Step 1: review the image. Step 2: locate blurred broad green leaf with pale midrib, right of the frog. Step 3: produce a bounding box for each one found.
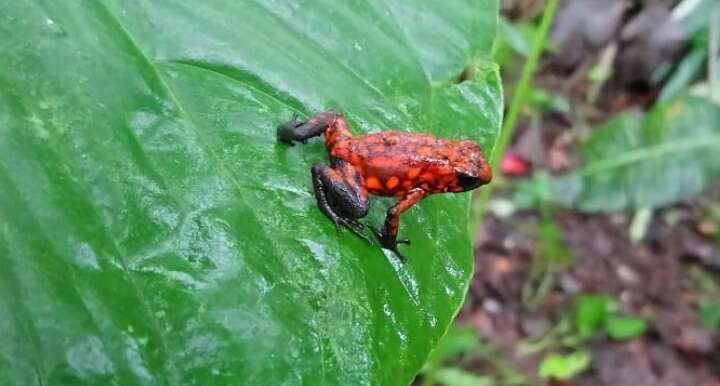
[552,97,720,211]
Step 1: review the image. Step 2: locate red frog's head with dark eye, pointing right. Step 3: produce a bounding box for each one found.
[448,141,492,192]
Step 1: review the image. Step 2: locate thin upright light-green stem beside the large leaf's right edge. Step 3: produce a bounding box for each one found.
[470,0,560,232]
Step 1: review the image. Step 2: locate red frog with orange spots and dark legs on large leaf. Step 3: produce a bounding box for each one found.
[276,110,492,262]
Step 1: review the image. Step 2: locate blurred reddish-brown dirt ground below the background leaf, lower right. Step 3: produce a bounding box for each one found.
[459,196,720,386]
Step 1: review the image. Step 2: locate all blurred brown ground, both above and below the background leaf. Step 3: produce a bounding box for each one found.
[458,0,720,386]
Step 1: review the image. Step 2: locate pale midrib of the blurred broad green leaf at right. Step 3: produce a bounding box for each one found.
[573,135,720,177]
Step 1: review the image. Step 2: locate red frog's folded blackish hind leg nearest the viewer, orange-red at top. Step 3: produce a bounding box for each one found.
[312,161,370,242]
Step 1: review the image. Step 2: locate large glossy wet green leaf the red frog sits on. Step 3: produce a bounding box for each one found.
[0,0,501,386]
